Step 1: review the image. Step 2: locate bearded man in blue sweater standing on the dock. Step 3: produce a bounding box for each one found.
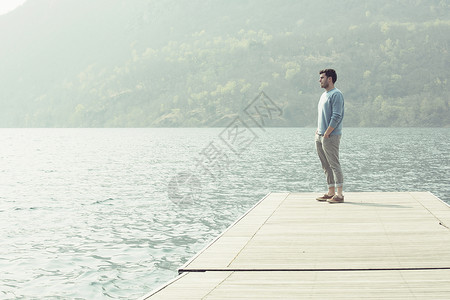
[315,69,344,203]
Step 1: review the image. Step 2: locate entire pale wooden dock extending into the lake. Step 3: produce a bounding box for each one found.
[142,192,450,300]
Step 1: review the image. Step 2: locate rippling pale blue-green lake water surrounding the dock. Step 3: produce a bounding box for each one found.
[0,128,450,299]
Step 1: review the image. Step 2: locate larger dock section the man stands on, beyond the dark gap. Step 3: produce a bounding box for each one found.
[182,193,450,271]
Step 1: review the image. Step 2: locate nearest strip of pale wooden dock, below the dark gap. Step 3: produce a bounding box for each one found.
[144,270,450,300]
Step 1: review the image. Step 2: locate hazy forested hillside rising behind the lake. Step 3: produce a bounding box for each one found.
[0,0,450,127]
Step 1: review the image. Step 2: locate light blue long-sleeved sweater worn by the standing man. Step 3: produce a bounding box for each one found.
[317,88,344,135]
